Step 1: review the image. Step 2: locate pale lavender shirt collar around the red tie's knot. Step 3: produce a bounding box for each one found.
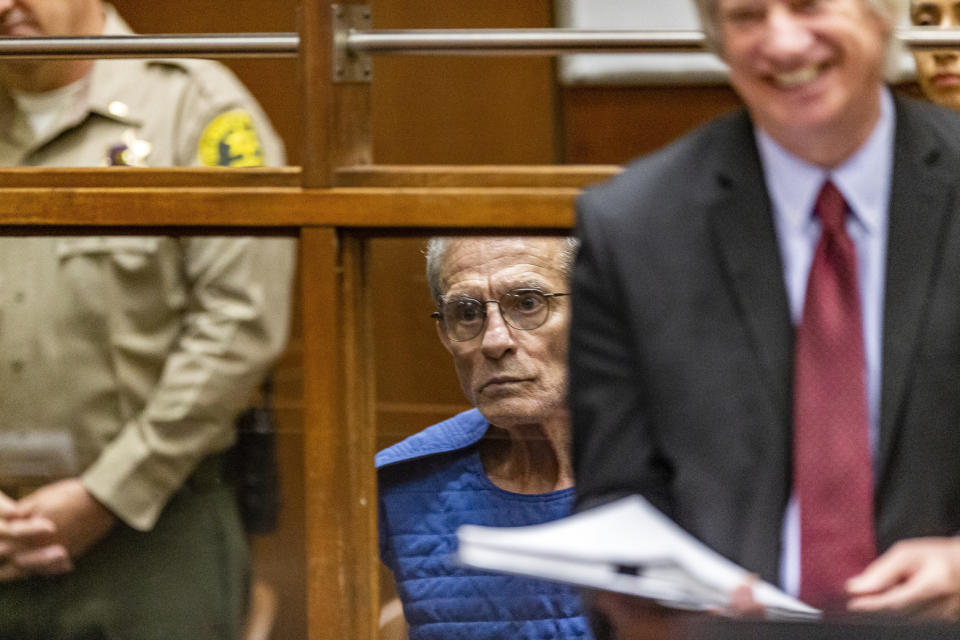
[755,87,895,233]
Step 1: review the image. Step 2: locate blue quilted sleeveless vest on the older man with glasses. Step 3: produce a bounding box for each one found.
[376,409,592,640]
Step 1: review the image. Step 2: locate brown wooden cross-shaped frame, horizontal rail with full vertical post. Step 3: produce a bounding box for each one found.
[0,0,616,640]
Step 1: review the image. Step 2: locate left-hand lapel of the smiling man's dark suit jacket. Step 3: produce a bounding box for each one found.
[708,115,793,437]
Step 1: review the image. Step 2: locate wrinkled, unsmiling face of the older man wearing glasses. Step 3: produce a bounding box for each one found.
[437,238,569,429]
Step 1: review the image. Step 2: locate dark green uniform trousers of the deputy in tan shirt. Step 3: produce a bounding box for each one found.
[0,475,249,640]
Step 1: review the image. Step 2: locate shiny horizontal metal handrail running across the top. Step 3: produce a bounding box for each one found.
[0,28,960,59]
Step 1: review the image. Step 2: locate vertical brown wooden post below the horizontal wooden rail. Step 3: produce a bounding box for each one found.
[301,228,379,640]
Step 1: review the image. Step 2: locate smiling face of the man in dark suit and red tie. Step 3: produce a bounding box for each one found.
[716,0,890,166]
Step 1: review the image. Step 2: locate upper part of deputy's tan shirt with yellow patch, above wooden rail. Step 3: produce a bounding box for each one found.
[0,6,285,167]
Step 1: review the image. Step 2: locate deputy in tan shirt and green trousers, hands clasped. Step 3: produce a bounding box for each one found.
[0,0,294,640]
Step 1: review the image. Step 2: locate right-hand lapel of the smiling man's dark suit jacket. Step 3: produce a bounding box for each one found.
[877,100,957,478]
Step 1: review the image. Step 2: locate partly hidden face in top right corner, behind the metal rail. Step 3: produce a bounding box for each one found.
[910,0,960,110]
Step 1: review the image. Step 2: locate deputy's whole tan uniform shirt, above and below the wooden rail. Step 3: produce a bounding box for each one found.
[0,8,294,530]
